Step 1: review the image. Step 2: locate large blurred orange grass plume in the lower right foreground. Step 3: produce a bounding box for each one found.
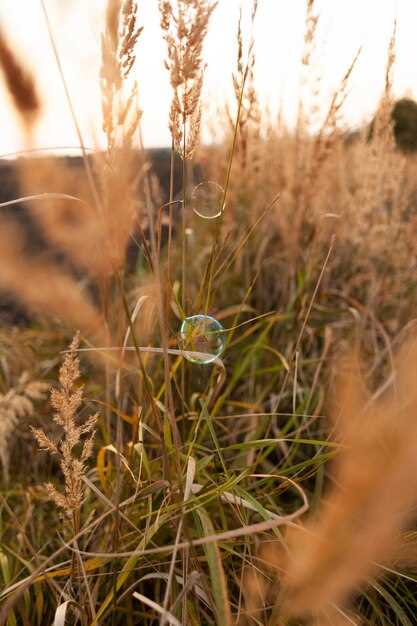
[254,340,417,623]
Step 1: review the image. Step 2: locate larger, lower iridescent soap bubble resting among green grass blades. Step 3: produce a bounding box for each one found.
[180,315,226,365]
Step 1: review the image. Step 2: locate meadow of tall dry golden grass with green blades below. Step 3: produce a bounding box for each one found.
[0,0,417,626]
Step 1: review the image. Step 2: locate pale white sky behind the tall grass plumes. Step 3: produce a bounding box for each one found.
[0,0,417,154]
